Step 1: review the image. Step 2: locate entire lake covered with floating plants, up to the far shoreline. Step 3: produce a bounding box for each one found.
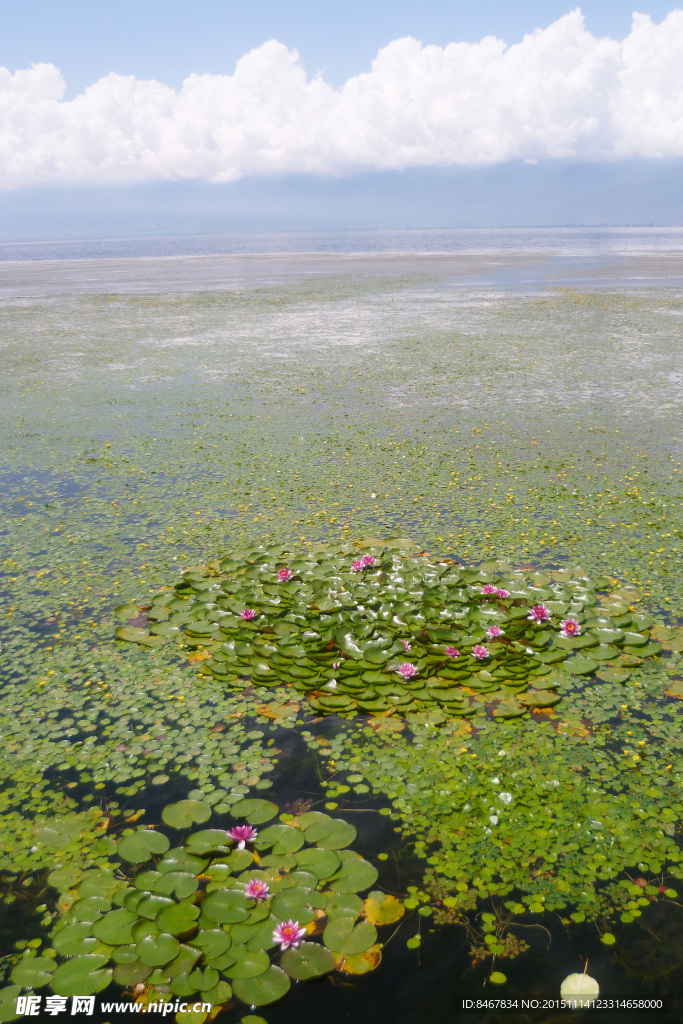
[0,228,683,1024]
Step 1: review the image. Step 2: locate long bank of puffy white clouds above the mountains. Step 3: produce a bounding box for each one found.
[0,10,683,187]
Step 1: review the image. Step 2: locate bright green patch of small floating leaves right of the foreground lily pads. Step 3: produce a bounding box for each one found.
[305,696,683,937]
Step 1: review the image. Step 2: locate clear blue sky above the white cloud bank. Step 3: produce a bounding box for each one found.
[0,0,675,98]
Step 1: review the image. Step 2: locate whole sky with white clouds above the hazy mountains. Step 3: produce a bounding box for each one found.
[0,0,683,207]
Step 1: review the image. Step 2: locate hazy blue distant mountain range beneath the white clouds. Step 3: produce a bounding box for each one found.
[0,160,683,242]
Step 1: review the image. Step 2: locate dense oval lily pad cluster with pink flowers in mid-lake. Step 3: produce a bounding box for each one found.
[117,538,659,718]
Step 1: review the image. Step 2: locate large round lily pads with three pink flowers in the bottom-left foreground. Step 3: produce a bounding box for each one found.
[10,799,403,1007]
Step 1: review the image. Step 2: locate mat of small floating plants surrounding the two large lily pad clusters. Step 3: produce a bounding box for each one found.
[0,259,683,1021]
